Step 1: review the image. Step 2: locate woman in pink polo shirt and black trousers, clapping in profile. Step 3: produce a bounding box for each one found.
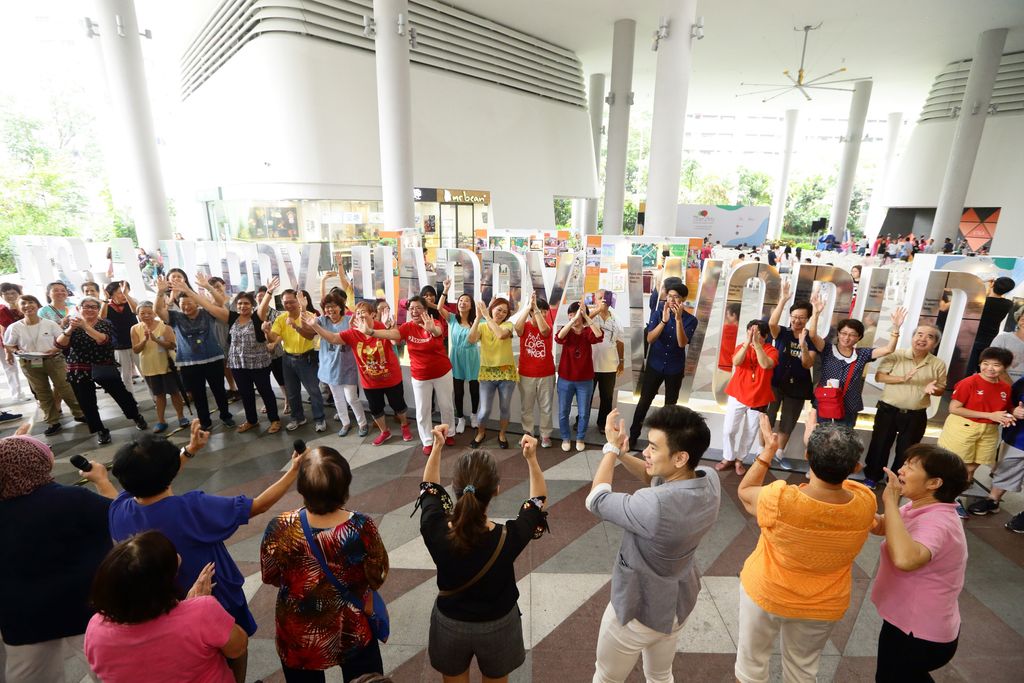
[871,443,968,683]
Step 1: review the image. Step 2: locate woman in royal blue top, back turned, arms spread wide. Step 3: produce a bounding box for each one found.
[110,421,305,681]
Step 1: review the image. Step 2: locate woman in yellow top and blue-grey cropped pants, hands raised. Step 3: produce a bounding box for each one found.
[469,297,519,449]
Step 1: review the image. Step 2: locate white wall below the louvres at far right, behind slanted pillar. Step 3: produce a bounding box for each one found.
[885,114,1024,256]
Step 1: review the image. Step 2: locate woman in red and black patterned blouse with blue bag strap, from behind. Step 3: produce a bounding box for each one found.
[260,446,388,682]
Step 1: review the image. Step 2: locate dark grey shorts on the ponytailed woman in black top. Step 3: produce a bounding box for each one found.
[427,602,526,678]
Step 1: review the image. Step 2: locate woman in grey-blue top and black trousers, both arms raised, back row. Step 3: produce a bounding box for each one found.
[156,275,236,431]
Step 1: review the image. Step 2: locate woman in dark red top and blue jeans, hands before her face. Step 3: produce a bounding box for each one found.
[555,301,604,453]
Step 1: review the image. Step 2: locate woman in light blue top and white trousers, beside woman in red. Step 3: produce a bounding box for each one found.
[315,290,370,436]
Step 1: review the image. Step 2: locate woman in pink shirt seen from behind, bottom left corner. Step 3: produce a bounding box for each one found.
[85,531,249,683]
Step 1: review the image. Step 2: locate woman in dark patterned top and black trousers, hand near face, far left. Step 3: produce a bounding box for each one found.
[55,297,148,445]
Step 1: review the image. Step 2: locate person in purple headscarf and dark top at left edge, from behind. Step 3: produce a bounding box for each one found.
[0,424,117,682]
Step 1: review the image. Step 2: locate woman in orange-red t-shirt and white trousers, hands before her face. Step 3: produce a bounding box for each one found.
[715,321,778,474]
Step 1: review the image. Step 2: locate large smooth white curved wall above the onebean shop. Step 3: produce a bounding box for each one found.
[182,35,597,237]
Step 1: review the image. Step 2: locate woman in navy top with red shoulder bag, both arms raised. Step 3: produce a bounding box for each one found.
[802,294,906,428]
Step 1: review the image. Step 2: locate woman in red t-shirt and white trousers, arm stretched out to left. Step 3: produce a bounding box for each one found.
[374,296,455,456]
